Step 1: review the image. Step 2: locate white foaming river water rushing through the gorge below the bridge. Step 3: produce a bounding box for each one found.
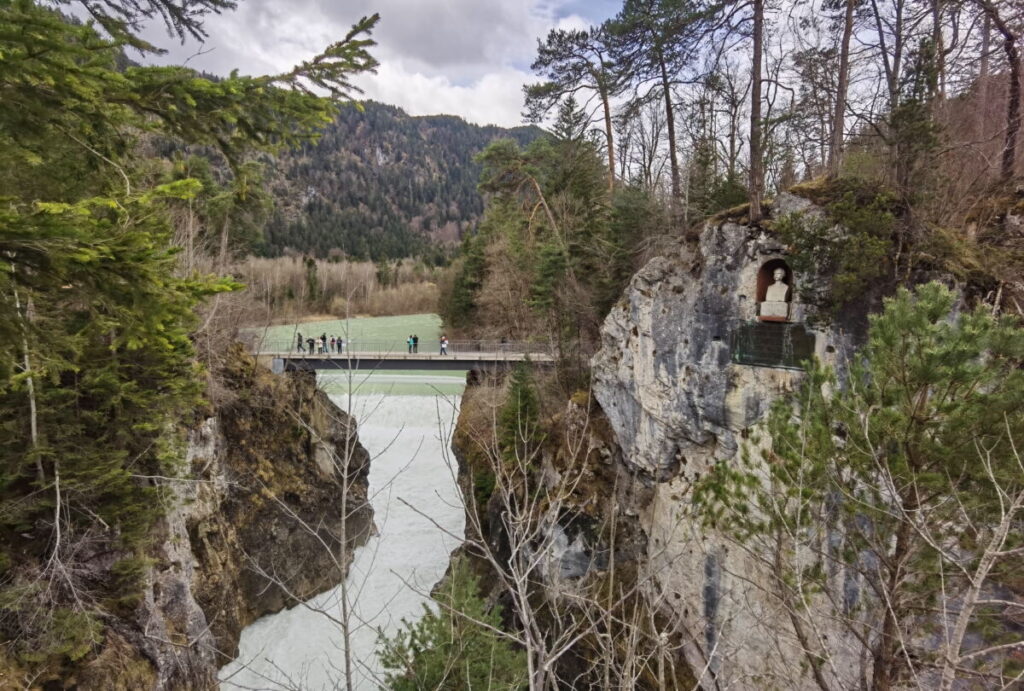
[220,386,465,691]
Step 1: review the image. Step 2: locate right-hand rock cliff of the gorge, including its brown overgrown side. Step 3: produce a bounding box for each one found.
[453,193,886,689]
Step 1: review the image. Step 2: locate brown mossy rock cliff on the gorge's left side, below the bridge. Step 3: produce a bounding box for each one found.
[74,351,373,689]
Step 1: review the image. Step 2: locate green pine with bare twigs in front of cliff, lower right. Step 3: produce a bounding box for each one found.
[694,283,1024,688]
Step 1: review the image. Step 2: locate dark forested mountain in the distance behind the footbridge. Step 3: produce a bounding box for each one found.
[262,101,541,260]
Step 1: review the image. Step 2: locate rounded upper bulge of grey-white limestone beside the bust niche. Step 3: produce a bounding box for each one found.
[593,195,847,478]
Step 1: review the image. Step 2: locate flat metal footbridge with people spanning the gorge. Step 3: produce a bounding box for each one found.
[252,339,555,372]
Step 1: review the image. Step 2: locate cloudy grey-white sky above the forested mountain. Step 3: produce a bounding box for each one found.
[133,0,621,126]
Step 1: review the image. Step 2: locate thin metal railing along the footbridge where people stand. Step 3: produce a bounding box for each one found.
[250,338,553,359]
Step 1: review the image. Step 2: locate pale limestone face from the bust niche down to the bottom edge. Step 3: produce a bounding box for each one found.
[592,195,864,689]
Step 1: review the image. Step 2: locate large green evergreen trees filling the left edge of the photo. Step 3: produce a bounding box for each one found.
[0,0,376,679]
